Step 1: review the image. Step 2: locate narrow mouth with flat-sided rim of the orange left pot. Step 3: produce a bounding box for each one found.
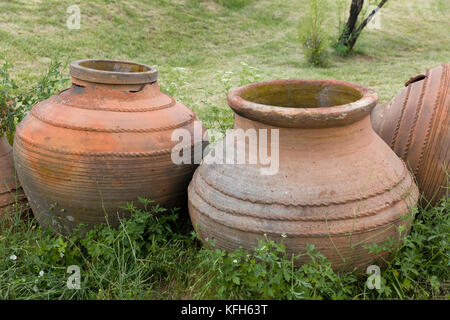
[70,59,158,84]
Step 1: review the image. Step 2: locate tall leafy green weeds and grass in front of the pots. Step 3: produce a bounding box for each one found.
[0,199,450,299]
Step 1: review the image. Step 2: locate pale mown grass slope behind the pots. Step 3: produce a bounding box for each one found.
[0,0,450,111]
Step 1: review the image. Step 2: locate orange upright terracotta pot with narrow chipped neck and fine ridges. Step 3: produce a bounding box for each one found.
[14,60,203,232]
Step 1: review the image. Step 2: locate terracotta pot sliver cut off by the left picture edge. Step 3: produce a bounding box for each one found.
[0,136,26,219]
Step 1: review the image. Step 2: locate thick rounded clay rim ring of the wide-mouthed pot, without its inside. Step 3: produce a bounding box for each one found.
[227,79,378,128]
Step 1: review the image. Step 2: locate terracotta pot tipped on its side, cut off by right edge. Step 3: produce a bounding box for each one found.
[371,64,450,204]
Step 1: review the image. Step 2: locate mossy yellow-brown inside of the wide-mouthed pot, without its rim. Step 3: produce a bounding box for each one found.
[241,81,363,108]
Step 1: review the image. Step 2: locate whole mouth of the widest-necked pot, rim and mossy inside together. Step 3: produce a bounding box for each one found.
[228,79,378,128]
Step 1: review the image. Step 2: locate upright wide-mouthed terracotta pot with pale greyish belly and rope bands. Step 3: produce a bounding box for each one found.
[189,80,418,269]
